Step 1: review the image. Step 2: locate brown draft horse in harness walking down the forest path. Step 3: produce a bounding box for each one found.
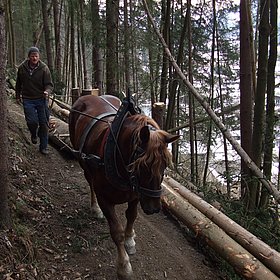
[69,95,178,279]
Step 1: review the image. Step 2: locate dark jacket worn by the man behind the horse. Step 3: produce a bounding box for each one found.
[16,59,53,99]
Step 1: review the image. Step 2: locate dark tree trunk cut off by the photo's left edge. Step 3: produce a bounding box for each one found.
[0,0,10,228]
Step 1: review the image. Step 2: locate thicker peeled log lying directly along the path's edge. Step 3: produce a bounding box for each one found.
[162,182,279,280]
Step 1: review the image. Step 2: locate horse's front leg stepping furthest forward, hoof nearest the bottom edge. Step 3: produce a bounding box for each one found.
[99,201,133,280]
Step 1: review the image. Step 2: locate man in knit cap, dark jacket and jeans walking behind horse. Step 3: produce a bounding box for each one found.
[16,47,53,155]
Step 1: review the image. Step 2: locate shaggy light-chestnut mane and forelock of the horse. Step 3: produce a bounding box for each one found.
[130,114,172,182]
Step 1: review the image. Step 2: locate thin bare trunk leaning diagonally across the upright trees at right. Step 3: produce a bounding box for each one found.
[143,0,280,203]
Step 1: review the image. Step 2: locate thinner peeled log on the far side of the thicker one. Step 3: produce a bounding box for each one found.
[164,177,280,278]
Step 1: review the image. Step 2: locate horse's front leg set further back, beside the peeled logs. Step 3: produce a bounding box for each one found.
[125,200,138,255]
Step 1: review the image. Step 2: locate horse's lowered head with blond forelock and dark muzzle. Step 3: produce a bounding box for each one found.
[122,115,179,214]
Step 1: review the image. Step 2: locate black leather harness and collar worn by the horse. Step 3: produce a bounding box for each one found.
[72,96,162,198]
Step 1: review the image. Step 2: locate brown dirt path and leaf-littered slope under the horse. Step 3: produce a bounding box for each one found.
[0,100,228,280]
